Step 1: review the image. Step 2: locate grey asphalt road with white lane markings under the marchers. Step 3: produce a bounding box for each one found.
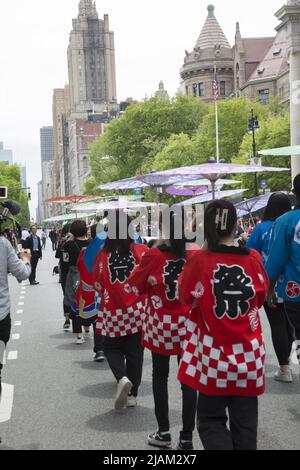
[0,242,300,450]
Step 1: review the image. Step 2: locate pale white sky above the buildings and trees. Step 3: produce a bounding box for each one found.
[0,0,284,216]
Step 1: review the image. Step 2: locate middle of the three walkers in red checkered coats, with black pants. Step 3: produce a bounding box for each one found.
[128,209,199,451]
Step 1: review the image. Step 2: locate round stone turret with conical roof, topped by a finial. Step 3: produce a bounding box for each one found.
[180,5,234,102]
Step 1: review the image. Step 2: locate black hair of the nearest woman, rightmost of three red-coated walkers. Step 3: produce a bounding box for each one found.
[204,199,237,251]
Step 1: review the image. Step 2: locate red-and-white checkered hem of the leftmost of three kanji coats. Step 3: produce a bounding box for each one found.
[96,302,145,338]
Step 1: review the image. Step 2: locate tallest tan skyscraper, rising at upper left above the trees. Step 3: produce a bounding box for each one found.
[68,0,117,119]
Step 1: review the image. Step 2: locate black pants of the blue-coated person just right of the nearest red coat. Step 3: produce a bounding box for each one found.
[265,303,294,366]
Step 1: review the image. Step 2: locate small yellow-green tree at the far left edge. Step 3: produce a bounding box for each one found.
[0,162,30,226]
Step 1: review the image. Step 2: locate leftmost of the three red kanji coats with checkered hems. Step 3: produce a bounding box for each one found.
[93,243,148,338]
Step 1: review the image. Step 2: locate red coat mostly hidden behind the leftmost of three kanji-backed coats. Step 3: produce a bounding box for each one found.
[72,250,98,320]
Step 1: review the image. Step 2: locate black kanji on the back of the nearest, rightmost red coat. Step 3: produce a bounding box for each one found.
[213,265,255,320]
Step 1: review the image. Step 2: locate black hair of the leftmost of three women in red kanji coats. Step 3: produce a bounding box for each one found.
[104,210,134,254]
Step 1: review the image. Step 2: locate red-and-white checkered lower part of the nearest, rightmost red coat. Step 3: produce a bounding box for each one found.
[180,321,266,395]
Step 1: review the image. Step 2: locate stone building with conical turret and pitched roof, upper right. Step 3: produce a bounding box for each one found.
[180,5,290,104]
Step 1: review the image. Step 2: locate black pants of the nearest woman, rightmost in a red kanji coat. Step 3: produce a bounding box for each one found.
[198,393,258,451]
